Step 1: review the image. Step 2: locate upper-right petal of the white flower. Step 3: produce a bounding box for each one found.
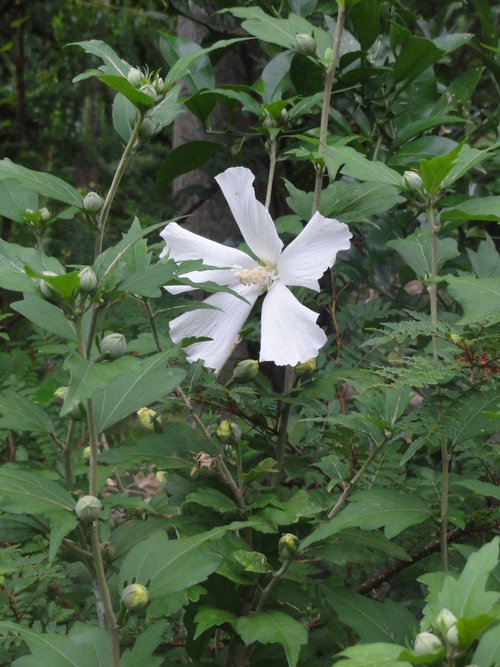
[278,213,352,291]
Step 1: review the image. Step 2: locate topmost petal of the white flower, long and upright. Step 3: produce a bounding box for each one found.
[215,167,283,265]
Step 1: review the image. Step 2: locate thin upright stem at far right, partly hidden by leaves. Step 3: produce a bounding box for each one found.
[426,204,450,571]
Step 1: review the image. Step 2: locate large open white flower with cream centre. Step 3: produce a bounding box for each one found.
[161,167,351,370]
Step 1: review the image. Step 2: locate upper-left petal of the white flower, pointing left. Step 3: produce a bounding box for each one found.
[160,222,255,268]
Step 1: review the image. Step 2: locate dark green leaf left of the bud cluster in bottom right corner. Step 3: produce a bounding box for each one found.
[324,586,418,646]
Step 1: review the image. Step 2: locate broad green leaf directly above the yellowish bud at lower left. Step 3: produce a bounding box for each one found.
[119,526,228,599]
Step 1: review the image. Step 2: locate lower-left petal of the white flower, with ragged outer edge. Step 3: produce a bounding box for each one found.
[170,283,261,369]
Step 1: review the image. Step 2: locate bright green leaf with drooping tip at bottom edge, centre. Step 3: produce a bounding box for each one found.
[236,610,308,667]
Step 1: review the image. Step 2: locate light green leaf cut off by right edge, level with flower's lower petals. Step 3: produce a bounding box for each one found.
[445,276,500,326]
